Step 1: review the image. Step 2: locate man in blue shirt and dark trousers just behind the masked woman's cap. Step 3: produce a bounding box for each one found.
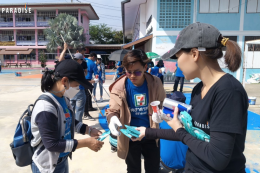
[85,53,98,120]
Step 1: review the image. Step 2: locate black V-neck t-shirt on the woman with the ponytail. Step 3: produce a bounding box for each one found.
[186,74,248,173]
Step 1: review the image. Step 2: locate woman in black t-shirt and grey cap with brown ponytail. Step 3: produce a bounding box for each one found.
[135,23,248,173]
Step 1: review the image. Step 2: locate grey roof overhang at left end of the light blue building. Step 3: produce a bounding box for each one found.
[121,0,147,41]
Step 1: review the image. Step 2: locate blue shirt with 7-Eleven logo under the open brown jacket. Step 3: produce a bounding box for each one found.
[125,79,150,127]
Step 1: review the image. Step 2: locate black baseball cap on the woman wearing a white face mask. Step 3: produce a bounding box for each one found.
[54,59,93,89]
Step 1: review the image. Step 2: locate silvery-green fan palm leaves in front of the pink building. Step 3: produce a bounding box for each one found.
[44,13,86,52]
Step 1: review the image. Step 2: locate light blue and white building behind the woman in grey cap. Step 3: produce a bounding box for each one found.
[121,0,260,82]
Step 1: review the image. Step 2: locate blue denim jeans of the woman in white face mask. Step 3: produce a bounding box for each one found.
[31,158,69,173]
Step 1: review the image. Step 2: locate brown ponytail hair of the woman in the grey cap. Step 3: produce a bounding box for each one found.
[200,35,242,72]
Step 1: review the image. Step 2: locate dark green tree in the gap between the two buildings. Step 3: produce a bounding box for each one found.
[89,24,130,44]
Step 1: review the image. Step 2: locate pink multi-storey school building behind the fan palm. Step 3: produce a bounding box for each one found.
[0,3,99,67]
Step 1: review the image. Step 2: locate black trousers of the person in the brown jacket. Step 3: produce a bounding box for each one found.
[125,139,160,173]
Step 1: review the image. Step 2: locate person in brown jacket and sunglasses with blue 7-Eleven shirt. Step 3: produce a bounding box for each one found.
[106,50,165,173]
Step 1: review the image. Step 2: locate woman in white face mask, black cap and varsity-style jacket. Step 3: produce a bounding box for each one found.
[31,59,103,173]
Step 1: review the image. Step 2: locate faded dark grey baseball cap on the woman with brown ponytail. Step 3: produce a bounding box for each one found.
[162,22,221,60]
